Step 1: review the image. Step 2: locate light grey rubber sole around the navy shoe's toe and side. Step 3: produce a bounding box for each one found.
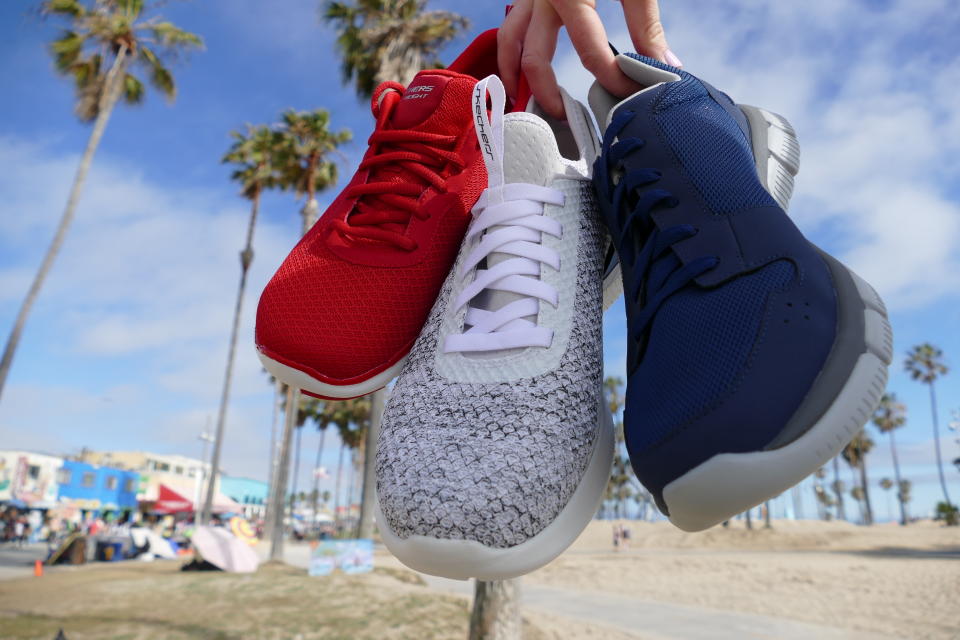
[663,271,893,531]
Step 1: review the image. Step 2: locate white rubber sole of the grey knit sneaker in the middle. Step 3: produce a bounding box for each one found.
[376,400,614,580]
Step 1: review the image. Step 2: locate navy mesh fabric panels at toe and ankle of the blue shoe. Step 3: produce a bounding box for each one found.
[612,54,796,455]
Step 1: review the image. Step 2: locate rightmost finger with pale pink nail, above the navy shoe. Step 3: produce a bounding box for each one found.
[557,2,640,97]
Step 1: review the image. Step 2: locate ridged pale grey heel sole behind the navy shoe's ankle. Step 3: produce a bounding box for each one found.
[739,104,800,211]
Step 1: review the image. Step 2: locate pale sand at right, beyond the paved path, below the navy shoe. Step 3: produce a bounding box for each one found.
[524,521,960,638]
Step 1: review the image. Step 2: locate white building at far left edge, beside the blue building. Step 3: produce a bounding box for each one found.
[0,450,63,510]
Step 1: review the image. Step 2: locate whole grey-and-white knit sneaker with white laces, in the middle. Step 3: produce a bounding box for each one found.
[377,76,614,580]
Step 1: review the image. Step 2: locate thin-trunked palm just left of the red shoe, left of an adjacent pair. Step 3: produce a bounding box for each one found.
[199,125,283,524]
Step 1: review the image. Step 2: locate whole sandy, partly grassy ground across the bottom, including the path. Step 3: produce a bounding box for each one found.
[0,521,960,640]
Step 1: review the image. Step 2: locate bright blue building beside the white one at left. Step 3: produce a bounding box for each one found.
[57,460,140,514]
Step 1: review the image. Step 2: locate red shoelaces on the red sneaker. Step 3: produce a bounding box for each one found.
[334,82,465,251]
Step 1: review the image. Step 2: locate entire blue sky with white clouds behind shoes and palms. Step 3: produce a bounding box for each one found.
[0,0,960,515]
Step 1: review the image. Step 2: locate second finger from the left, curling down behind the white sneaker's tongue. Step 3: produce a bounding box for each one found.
[511,0,563,119]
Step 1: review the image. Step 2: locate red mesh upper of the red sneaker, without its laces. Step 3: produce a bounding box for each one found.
[256,71,486,380]
